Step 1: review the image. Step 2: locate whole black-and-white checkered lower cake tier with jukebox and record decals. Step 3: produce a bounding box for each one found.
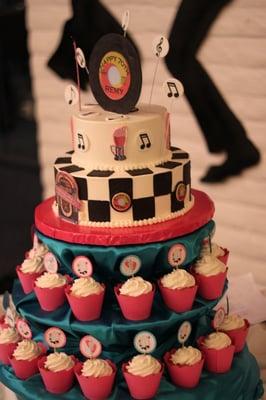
[54,147,193,227]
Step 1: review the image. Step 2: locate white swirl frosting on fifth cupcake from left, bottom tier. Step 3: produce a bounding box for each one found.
[126,354,161,376]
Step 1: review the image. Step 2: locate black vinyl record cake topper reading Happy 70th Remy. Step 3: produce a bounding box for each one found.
[89,33,142,114]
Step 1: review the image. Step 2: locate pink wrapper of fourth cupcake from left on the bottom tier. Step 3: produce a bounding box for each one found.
[74,360,117,400]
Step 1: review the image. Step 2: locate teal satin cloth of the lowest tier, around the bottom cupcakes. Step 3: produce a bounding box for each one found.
[0,348,263,400]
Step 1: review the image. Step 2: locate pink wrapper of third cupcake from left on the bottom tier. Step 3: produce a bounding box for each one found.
[38,356,76,394]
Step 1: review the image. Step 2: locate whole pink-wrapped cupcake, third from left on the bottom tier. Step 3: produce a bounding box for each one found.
[38,352,76,394]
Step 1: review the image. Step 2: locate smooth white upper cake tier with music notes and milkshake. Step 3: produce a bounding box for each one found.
[71,105,171,171]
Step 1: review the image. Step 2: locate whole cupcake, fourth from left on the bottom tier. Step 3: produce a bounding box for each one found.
[75,358,116,400]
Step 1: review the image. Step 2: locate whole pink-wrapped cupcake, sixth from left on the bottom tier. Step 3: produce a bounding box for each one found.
[164,346,204,388]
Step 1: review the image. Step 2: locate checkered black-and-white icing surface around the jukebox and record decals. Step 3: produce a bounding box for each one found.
[55,147,191,223]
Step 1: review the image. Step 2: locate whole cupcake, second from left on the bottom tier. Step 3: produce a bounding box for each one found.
[10,340,46,380]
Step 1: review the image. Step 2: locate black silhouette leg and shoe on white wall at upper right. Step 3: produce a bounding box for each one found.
[165,0,260,182]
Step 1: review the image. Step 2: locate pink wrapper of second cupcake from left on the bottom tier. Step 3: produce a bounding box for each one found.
[9,343,47,380]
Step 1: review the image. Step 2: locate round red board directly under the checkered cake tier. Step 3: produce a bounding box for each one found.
[35,189,214,246]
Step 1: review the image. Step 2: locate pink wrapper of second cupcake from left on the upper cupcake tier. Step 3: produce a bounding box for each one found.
[34,275,72,311]
